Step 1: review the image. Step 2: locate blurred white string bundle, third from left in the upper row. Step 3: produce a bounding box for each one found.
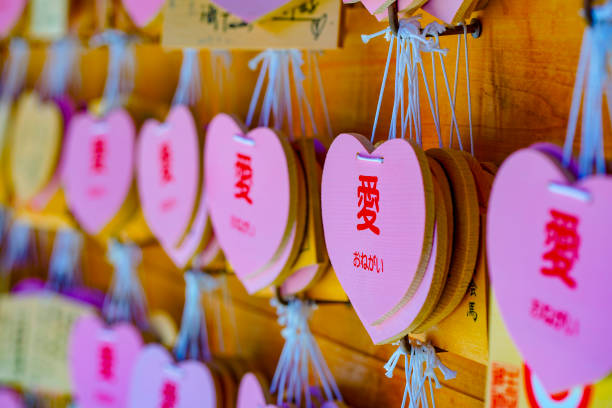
[90,30,135,114]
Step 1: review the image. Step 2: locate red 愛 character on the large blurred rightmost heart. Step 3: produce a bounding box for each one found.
[541,210,580,289]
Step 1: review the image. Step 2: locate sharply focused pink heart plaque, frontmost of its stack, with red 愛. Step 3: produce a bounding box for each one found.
[321,133,435,325]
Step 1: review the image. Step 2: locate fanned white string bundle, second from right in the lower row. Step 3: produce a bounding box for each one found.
[270,299,342,408]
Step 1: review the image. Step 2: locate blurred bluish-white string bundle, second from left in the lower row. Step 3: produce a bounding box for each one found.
[47,228,83,292]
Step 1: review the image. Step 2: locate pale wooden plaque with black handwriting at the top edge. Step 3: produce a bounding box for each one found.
[162,0,340,50]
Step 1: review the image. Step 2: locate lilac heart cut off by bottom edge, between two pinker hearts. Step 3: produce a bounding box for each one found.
[126,344,218,408]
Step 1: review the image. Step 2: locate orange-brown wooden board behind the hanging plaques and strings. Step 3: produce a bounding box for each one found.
[7,0,609,408]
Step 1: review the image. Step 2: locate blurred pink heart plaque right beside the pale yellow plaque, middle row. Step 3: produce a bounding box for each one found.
[62,109,135,235]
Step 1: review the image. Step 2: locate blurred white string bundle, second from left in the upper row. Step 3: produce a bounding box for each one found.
[38,37,80,98]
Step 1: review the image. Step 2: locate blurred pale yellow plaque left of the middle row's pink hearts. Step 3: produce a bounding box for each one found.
[10,92,63,203]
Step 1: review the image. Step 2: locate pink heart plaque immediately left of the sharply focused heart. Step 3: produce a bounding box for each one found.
[204,114,298,279]
